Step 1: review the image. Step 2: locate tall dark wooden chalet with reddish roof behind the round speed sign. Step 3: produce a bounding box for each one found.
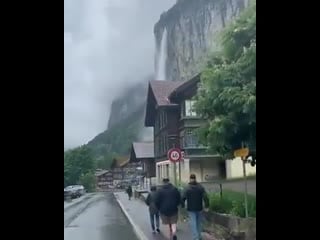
[145,75,255,183]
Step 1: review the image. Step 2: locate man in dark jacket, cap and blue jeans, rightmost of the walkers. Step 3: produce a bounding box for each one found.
[182,174,209,240]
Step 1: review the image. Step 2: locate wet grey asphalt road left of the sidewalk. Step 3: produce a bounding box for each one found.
[64,193,138,240]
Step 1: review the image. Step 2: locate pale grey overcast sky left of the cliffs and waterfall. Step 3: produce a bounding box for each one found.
[64,0,175,148]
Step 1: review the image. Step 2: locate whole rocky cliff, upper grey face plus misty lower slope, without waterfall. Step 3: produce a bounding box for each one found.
[88,0,248,163]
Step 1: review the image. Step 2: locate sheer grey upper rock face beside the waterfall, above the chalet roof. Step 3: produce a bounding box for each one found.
[154,0,248,81]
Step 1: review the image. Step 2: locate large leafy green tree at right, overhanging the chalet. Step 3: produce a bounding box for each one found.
[195,2,256,156]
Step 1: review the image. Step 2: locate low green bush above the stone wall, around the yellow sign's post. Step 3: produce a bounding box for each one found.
[209,191,256,217]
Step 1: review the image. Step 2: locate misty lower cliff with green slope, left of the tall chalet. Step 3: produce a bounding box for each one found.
[87,76,153,159]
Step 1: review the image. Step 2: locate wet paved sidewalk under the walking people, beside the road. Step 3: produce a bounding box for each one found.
[114,192,212,240]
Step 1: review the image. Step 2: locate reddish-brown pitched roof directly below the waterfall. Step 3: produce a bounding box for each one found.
[150,80,184,106]
